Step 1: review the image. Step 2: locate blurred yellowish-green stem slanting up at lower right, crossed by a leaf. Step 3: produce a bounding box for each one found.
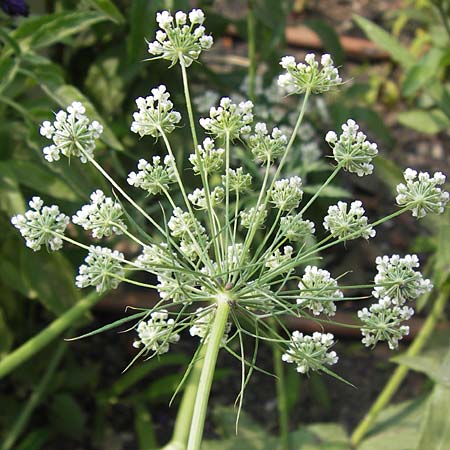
[351,283,450,447]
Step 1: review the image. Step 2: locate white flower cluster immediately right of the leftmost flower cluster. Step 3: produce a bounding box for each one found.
[72,189,127,239]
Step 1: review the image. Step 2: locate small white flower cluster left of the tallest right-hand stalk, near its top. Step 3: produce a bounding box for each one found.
[248,123,287,164]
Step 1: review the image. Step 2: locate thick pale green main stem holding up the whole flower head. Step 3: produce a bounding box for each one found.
[187,293,231,450]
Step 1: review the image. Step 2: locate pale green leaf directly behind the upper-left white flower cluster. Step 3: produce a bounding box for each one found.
[41,84,124,151]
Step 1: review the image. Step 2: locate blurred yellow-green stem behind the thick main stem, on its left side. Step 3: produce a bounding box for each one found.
[163,346,206,450]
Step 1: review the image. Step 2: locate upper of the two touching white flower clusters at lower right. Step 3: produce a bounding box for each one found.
[372,255,433,305]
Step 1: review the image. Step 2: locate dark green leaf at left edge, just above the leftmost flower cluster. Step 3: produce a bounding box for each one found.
[4,160,78,201]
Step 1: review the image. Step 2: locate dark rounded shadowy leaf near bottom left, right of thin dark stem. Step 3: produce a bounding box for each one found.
[50,393,86,441]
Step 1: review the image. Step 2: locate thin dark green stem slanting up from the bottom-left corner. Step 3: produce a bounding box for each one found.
[1,342,67,450]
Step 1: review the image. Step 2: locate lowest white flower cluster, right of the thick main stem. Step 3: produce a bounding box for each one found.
[282,331,339,373]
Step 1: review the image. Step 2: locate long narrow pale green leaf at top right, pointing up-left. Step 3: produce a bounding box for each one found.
[353,15,414,69]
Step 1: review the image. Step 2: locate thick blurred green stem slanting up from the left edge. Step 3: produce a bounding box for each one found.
[0,292,101,379]
